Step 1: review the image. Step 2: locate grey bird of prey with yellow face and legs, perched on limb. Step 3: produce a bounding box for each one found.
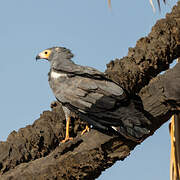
[36,47,151,143]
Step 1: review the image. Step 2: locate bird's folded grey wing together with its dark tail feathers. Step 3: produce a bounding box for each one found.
[55,76,150,140]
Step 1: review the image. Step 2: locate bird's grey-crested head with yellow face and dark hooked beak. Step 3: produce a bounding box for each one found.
[36,47,73,62]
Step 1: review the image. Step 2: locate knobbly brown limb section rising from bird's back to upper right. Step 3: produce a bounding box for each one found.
[106,2,180,93]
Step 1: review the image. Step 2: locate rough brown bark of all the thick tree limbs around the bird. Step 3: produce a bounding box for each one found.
[0,3,180,180]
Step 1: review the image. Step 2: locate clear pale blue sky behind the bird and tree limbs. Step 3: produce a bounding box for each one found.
[0,0,176,180]
